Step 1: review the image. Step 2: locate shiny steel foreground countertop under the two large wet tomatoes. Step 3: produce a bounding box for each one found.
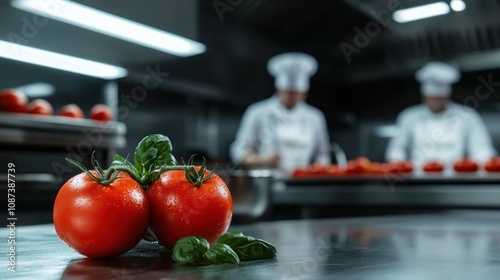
[0,211,500,280]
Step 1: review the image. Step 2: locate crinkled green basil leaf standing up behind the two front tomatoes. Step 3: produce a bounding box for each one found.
[134,134,177,177]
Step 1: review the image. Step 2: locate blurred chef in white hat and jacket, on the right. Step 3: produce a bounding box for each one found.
[386,62,496,167]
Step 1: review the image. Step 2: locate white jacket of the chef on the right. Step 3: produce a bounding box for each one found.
[386,102,496,166]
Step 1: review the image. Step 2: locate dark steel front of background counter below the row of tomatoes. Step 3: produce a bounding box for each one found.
[272,171,500,218]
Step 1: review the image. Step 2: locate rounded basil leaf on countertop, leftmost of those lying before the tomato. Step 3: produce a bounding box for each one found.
[172,236,210,263]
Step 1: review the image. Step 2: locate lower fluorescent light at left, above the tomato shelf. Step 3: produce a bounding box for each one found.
[0,40,127,80]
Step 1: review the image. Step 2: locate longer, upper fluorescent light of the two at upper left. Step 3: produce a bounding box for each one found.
[11,0,206,56]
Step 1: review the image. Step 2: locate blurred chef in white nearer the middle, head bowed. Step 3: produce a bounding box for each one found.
[230,52,331,175]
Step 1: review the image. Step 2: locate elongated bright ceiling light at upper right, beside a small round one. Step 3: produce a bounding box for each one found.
[392,2,450,23]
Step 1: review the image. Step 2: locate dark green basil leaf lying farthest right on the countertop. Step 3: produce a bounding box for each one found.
[219,234,278,261]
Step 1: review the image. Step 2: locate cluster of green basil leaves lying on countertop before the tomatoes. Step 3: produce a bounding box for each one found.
[172,231,278,264]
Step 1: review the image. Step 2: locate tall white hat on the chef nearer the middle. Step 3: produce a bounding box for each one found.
[267,52,318,93]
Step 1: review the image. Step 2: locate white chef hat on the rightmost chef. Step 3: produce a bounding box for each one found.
[415,61,460,97]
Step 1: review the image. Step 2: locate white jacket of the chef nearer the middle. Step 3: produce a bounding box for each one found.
[230,95,331,173]
